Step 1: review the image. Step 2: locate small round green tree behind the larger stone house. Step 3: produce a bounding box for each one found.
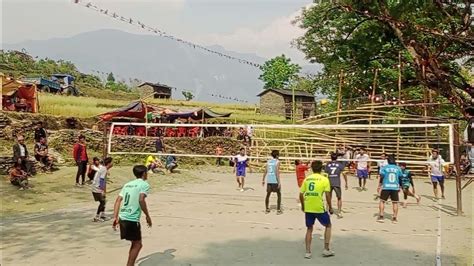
[259,55,301,89]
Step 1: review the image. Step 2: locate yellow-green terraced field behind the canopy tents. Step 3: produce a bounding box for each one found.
[39,92,285,123]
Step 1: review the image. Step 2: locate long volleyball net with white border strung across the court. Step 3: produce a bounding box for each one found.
[107,122,454,164]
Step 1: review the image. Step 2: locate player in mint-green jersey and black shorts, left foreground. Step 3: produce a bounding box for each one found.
[112,165,152,266]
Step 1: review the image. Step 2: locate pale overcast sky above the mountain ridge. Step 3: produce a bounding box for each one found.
[0,0,312,63]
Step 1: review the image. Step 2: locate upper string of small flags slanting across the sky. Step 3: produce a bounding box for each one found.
[74,0,261,68]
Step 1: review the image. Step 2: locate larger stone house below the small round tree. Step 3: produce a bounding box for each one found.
[257,89,316,119]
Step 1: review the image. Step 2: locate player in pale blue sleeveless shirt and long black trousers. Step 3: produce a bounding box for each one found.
[262,150,283,214]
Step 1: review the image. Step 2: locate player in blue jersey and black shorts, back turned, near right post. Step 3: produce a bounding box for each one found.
[377,154,403,223]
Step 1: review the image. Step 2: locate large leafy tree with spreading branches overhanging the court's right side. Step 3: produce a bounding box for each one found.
[296,0,474,113]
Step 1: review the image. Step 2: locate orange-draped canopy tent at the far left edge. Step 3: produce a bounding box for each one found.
[0,73,38,113]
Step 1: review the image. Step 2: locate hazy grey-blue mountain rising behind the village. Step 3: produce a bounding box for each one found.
[3,30,320,103]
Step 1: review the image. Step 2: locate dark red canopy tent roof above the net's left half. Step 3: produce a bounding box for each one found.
[99,101,231,122]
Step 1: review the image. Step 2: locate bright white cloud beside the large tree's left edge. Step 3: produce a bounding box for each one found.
[197,6,305,63]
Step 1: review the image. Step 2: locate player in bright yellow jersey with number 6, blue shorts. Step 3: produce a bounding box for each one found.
[300,161,334,259]
